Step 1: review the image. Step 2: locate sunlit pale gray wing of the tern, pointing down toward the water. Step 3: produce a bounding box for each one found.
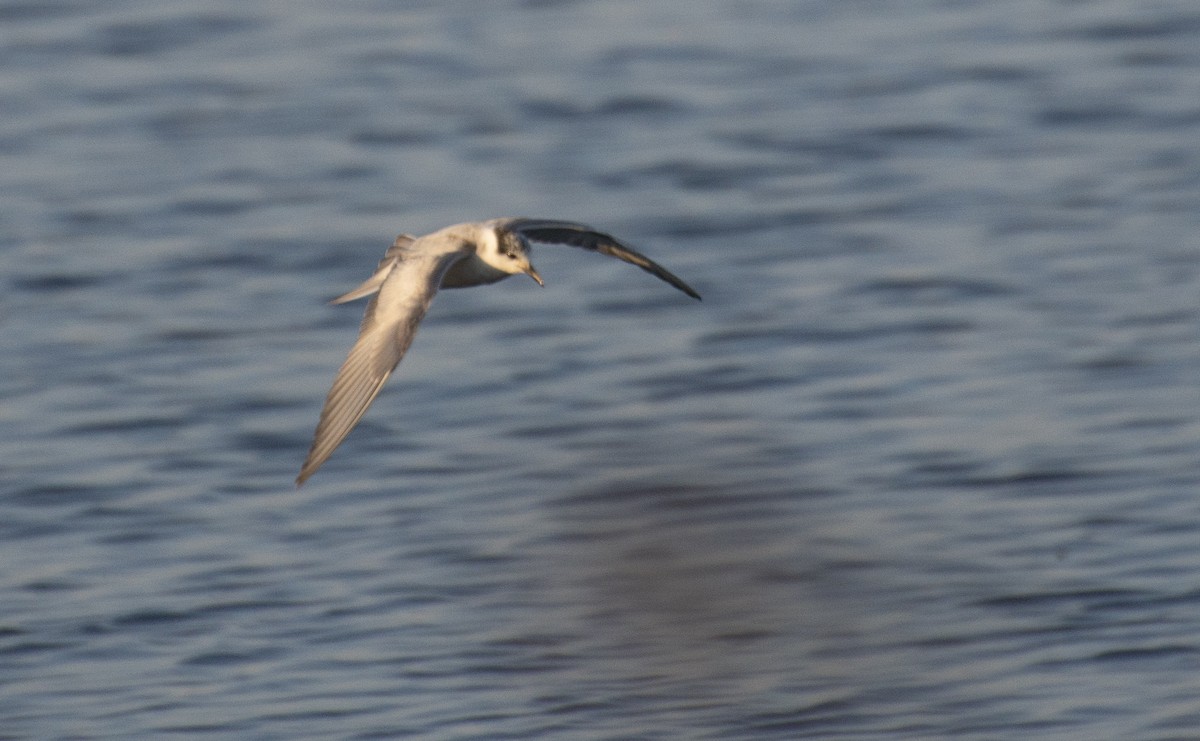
[296,242,467,486]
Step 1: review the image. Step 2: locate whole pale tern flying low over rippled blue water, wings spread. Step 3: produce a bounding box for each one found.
[295,217,700,487]
